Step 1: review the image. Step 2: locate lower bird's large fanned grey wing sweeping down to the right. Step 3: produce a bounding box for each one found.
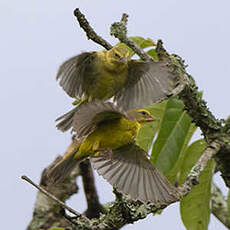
[90,144,178,204]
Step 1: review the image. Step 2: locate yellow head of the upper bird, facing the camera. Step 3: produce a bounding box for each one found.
[106,46,129,68]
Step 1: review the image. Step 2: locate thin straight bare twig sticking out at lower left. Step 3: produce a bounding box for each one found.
[21,176,89,221]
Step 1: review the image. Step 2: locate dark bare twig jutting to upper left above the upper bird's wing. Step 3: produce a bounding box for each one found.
[74,8,113,50]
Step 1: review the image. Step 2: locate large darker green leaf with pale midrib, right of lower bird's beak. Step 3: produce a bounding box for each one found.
[151,98,191,175]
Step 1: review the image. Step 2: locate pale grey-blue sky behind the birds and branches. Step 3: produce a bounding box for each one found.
[0,0,230,230]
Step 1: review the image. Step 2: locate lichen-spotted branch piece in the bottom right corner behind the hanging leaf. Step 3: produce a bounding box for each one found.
[211,184,230,229]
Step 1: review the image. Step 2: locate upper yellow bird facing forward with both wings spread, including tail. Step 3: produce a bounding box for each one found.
[57,46,179,131]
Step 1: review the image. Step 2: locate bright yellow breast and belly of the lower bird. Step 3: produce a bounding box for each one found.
[78,118,140,155]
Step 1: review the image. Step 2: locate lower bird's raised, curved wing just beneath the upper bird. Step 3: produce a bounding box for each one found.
[73,100,126,138]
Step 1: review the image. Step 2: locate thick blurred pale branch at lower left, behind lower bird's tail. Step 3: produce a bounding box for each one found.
[27,140,80,230]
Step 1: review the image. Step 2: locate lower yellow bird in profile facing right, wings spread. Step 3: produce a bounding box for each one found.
[48,100,178,203]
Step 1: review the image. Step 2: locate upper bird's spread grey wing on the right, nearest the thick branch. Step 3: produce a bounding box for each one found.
[114,59,180,110]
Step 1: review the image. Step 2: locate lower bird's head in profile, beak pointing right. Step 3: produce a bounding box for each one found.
[127,109,155,123]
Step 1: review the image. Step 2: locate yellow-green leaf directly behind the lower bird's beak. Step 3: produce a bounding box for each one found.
[136,101,167,152]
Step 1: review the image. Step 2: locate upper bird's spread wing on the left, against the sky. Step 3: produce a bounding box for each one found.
[56,52,97,98]
